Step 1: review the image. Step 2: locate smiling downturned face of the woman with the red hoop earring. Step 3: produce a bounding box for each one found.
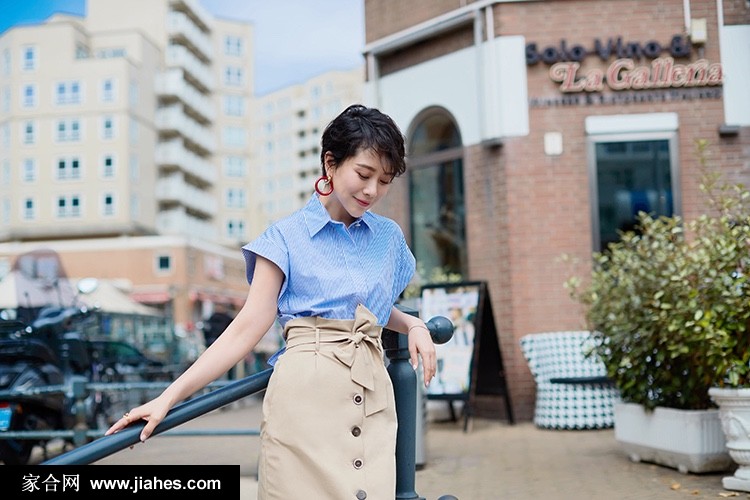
[321,149,393,225]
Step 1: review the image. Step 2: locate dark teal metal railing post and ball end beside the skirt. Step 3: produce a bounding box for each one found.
[383,307,453,500]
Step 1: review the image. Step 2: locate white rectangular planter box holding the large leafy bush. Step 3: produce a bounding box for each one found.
[614,403,733,473]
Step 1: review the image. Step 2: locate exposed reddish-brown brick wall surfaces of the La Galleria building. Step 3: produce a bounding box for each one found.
[366,0,750,420]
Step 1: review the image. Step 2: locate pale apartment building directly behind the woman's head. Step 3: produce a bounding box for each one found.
[248,67,364,239]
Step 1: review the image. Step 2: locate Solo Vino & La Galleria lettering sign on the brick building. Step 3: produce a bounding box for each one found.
[526,35,723,93]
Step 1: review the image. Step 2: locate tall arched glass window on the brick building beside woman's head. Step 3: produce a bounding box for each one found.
[409,110,468,276]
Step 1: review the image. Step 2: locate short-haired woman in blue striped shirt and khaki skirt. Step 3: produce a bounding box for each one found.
[107,105,435,500]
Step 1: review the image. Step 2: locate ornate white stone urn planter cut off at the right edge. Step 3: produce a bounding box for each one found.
[708,387,750,491]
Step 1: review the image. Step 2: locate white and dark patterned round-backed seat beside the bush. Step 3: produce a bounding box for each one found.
[521,331,620,429]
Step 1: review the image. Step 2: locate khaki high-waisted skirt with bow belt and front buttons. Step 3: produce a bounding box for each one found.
[258,305,396,500]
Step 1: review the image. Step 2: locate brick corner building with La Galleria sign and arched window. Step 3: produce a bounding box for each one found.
[364,0,750,419]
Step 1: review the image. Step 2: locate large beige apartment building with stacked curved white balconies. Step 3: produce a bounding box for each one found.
[0,0,253,331]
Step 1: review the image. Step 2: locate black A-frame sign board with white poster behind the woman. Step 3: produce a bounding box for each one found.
[421,281,514,430]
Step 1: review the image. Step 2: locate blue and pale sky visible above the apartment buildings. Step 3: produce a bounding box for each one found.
[0,0,365,95]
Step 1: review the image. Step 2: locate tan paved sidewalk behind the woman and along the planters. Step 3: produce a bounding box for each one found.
[44,397,750,500]
